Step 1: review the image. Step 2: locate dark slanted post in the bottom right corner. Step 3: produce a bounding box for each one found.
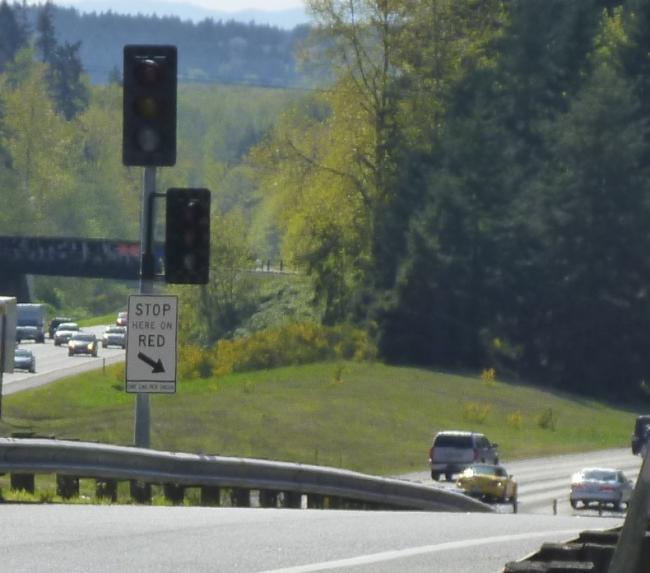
[608,447,650,573]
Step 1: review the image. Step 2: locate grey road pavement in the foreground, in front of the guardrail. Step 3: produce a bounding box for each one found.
[0,505,621,573]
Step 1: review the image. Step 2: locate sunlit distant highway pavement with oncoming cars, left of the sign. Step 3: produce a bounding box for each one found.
[2,325,124,395]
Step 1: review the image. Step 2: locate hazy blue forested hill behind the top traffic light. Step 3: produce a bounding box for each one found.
[22,0,309,87]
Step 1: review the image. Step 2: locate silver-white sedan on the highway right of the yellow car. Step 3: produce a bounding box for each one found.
[569,468,634,511]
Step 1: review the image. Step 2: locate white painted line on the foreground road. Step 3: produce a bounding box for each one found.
[260,529,580,573]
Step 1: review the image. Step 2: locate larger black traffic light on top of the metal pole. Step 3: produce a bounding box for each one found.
[122,45,177,167]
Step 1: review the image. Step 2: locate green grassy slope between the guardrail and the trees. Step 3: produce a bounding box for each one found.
[0,363,635,474]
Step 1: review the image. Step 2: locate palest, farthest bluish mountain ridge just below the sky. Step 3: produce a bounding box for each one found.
[55,0,308,30]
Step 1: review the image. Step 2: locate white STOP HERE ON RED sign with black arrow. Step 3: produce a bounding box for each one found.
[126,295,178,394]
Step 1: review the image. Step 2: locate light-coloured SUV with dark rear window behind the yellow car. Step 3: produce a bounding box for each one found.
[429,431,499,481]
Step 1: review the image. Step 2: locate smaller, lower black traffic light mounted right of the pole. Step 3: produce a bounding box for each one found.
[165,189,210,284]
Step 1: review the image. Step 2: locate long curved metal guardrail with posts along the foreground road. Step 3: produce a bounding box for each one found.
[0,438,493,512]
